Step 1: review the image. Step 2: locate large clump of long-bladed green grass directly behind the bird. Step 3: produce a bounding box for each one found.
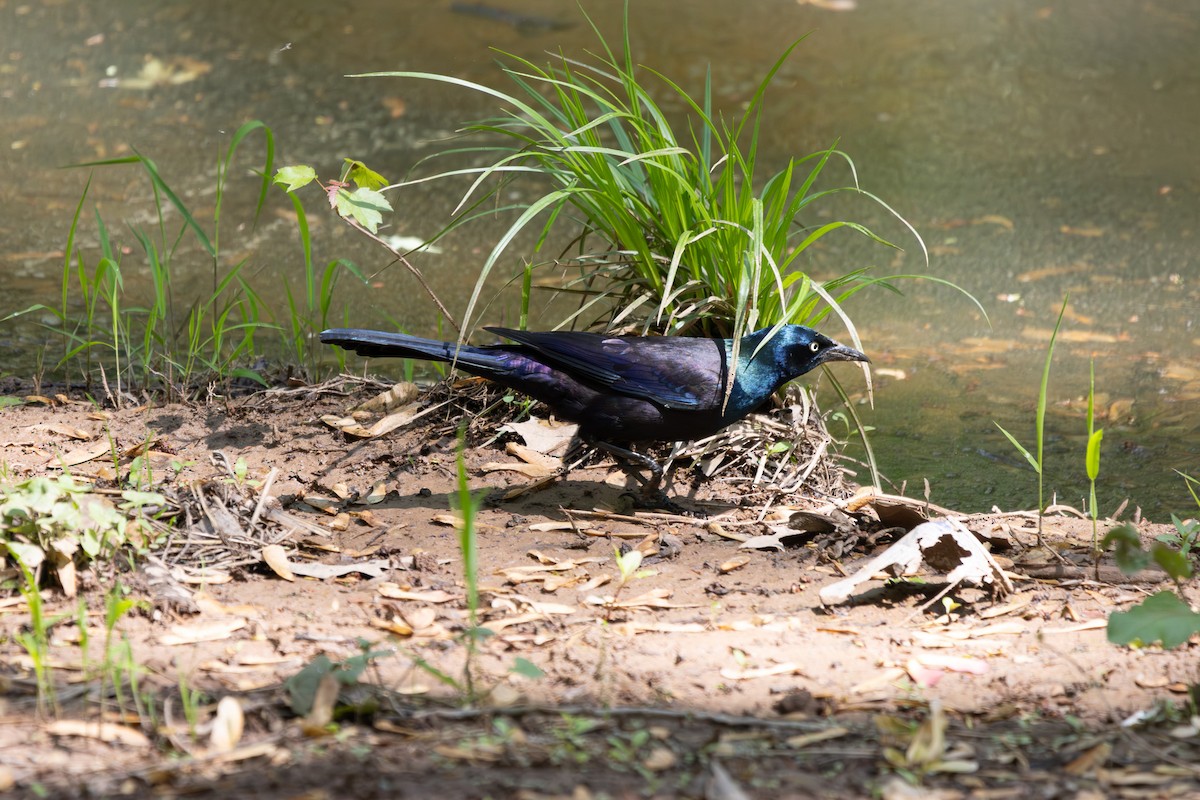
[338,4,974,343]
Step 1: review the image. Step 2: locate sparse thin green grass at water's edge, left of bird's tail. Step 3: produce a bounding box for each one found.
[0,120,365,393]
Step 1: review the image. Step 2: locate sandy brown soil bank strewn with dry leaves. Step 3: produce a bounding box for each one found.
[0,385,1200,798]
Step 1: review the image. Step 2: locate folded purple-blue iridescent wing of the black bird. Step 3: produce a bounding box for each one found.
[486,327,727,409]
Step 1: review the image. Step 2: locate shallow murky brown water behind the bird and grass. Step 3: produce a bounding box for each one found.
[0,0,1200,519]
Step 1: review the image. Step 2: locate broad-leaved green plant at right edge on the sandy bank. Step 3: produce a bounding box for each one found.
[1103,524,1200,650]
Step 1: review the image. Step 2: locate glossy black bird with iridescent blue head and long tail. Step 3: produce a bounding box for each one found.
[320,325,870,501]
